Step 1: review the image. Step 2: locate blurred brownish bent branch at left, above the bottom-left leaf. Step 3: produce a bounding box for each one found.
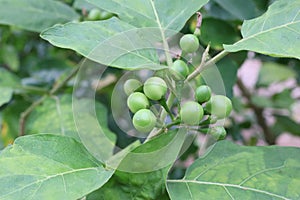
[19,66,80,136]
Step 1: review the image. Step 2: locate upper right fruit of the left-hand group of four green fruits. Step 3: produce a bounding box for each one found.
[144,77,167,100]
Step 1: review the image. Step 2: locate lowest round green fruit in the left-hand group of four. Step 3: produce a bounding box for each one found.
[132,109,156,133]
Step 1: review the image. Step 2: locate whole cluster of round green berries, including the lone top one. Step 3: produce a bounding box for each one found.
[124,34,232,139]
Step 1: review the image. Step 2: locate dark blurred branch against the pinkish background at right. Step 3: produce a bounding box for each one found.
[237,78,275,145]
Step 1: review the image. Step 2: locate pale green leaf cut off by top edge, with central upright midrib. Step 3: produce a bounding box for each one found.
[88,0,208,31]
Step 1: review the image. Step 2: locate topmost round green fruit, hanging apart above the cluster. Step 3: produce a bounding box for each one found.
[179,34,199,53]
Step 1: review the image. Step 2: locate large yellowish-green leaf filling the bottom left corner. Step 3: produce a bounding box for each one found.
[0,134,113,200]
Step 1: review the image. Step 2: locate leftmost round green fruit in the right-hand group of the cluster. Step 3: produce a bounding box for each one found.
[180,101,204,125]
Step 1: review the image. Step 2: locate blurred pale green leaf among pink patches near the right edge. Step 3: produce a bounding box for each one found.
[256,62,296,86]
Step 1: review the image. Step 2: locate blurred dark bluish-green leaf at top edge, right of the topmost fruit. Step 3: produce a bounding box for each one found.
[214,0,261,20]
